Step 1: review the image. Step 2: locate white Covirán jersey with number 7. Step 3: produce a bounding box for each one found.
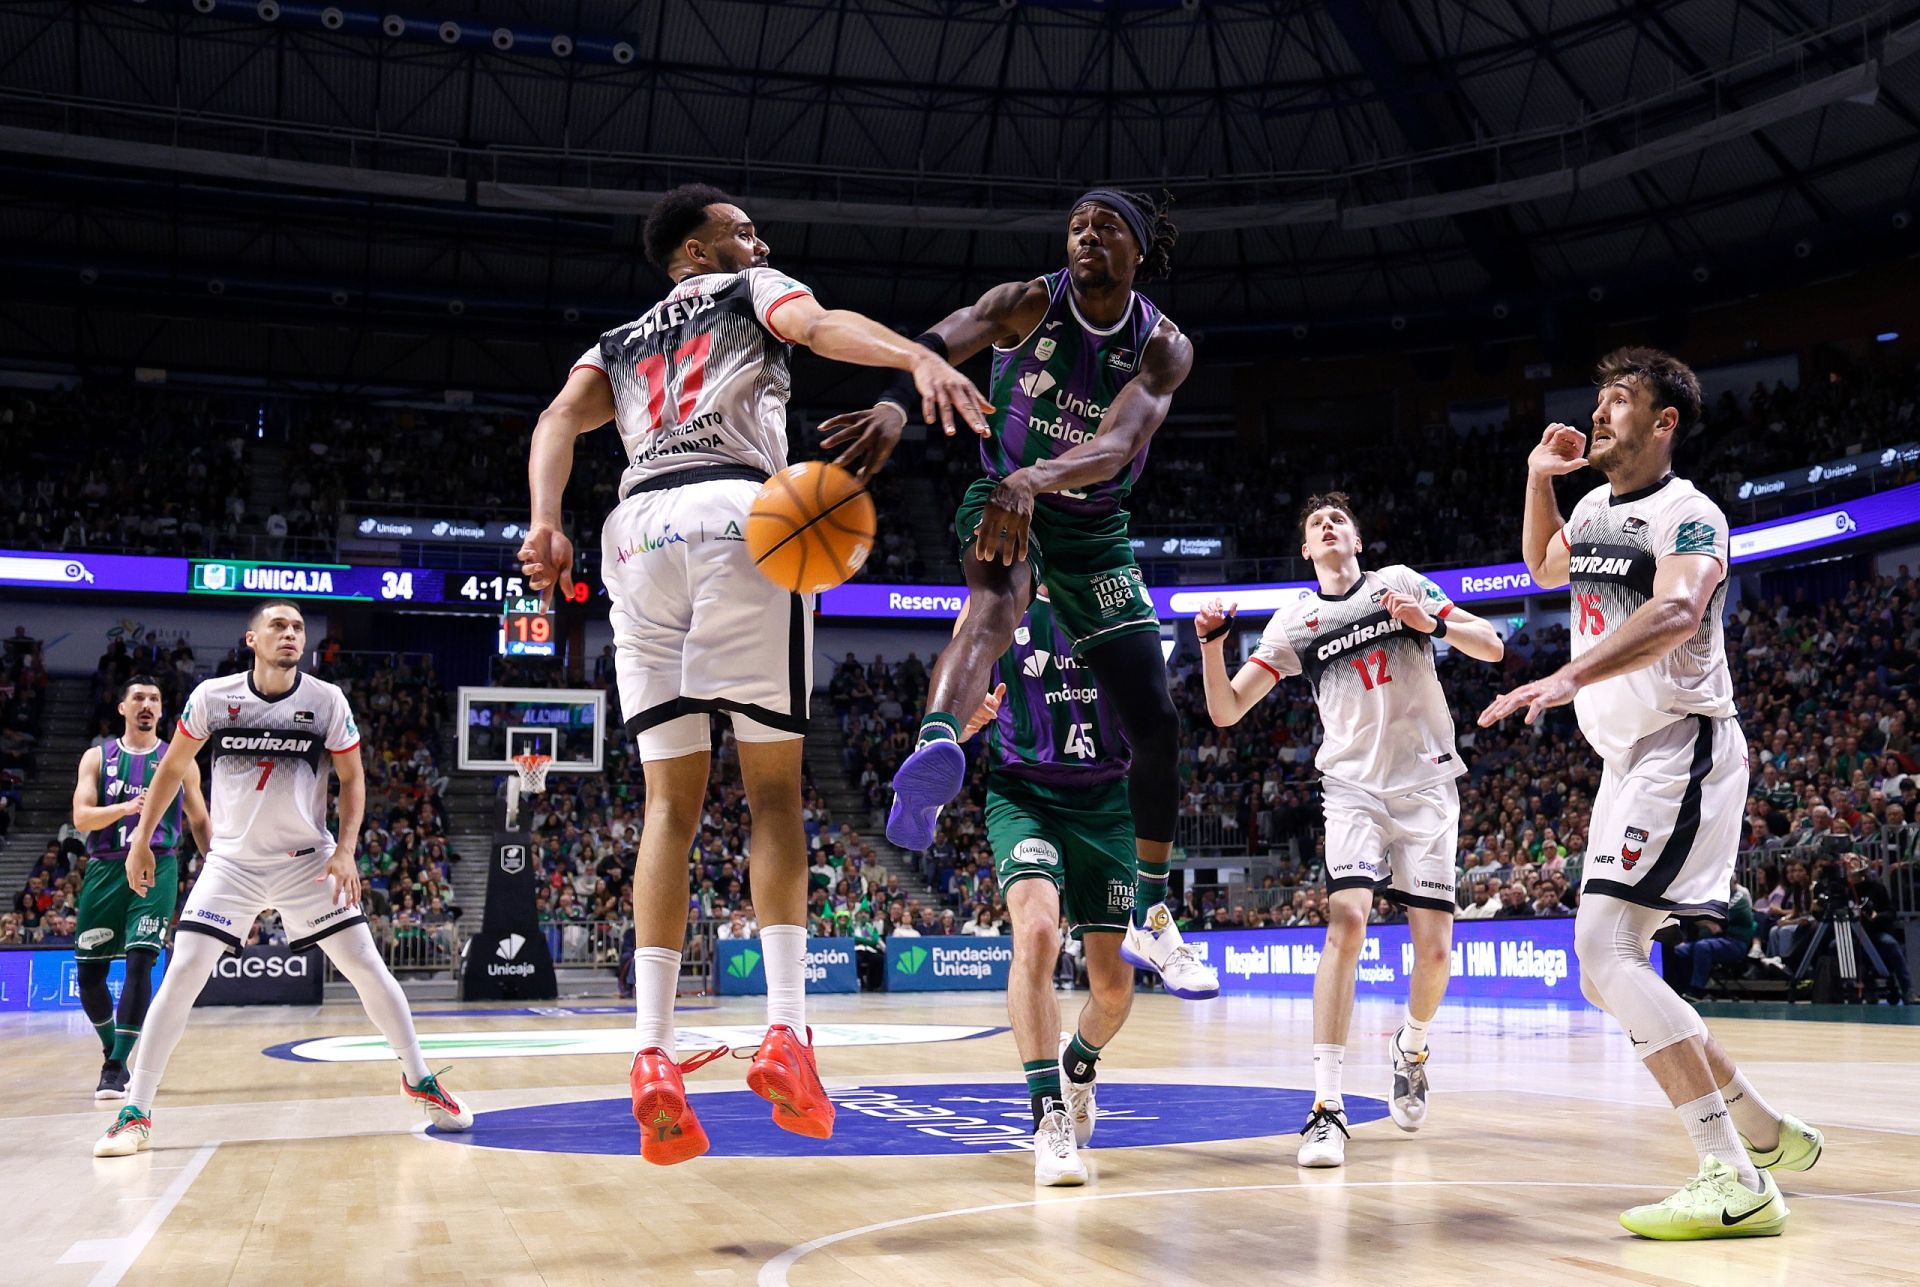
[179,670,359,859]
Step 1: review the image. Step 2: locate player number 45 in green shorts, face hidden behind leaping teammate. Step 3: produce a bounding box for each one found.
[954,586,1135,1187]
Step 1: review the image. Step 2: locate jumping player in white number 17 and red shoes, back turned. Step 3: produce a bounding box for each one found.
[520,184,991,1166]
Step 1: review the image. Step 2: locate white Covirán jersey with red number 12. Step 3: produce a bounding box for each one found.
[1252,563,1467,795]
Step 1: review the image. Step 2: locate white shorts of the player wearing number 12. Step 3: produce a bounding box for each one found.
[1321,778,1459,916]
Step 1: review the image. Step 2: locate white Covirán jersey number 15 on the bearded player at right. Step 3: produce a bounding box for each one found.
[1561,474,1734,759]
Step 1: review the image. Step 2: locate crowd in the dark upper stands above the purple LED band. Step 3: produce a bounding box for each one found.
[0,361,1920,582]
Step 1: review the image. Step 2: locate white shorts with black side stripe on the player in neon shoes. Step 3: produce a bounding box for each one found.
[1580,715,1747,920]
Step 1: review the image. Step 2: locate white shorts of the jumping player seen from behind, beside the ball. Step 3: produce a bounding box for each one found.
[601,471,814,761]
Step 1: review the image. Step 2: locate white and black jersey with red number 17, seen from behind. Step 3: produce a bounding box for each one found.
[574,269,812,499]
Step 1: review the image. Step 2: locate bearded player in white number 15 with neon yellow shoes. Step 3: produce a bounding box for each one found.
[1480,348,1822,1241]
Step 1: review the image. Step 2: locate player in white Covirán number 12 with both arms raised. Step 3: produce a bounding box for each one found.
[1194,492,1505,1166]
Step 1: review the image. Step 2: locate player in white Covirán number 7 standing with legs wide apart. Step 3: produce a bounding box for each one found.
[94,599,472,1158]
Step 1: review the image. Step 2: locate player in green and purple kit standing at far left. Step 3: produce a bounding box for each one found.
[73,674,213,1099]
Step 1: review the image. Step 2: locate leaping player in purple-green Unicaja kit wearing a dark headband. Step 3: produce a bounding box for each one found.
[822,188,1219,997]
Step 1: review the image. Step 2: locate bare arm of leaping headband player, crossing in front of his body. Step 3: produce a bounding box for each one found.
[973,317,1194,565]
